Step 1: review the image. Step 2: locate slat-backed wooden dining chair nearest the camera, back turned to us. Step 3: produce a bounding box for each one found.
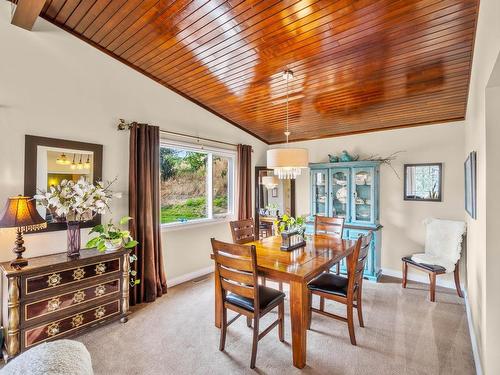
[211,238,285,369]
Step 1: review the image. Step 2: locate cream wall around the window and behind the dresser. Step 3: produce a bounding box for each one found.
[0,1,267,280]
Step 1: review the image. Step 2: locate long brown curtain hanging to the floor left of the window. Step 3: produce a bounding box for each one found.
[129,123,167,305]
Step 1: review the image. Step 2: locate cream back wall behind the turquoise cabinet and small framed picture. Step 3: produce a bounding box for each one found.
[293,122,464,282]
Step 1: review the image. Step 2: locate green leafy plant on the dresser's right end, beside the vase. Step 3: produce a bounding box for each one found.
[86,216,138,253]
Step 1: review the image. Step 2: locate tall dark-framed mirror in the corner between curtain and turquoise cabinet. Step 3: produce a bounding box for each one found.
[254,167,295,238]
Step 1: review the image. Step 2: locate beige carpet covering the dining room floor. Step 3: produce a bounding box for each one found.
[77,277,474,375]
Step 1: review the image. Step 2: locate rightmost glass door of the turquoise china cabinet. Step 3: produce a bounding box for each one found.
[351,167,375,224]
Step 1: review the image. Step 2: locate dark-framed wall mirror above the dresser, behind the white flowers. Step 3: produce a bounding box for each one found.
[24,135,102,231]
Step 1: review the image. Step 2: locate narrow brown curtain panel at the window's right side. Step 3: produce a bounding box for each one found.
[238,145,252,220]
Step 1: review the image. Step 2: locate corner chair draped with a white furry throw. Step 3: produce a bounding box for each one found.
[401,218,466,302]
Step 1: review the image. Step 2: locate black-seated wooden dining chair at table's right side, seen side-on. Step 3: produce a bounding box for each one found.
[308,231,373,345]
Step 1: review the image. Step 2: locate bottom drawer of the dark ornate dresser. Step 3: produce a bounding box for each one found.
[23,299,120,350]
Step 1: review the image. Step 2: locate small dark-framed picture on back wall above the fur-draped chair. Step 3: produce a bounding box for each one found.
[404,163,443,202]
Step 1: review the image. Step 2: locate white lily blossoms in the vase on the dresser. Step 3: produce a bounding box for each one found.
[34,177,115,221]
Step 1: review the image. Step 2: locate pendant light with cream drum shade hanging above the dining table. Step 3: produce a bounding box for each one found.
[267,70,309,179]
